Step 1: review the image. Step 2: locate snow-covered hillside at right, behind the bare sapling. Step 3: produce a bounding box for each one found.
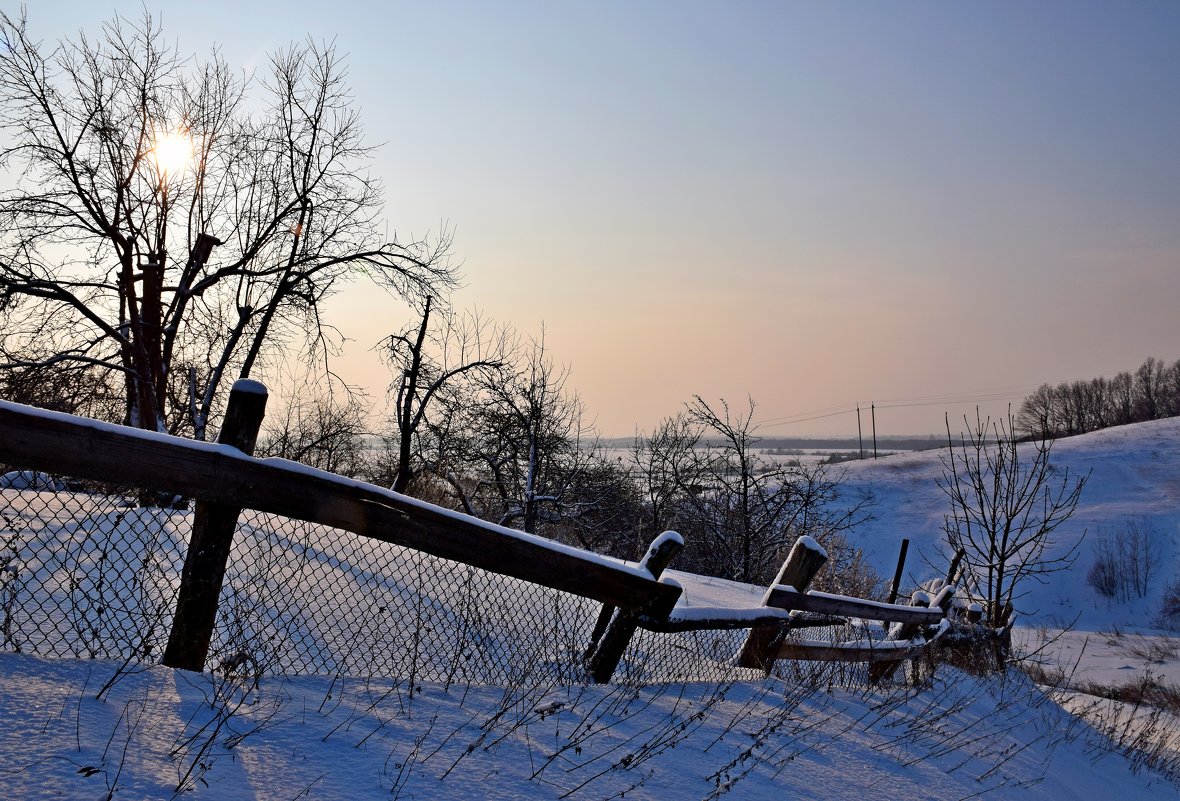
[844,419,1180,688]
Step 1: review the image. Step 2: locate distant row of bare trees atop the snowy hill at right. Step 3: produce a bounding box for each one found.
[1016,356,1180,439]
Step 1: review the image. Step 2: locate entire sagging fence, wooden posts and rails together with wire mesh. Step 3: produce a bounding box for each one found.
[0,382,950,683]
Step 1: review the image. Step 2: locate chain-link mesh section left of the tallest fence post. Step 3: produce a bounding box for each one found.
[0,478,182,661]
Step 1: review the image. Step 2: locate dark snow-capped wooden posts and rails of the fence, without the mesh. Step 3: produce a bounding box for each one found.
[0,381,952,682]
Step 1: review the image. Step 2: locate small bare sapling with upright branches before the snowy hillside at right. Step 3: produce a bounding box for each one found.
[938,412,1089,628]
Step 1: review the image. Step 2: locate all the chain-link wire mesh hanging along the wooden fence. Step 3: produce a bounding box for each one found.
[0,474,910,685]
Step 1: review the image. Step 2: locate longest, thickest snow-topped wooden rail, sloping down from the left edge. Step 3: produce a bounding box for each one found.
[0,401,680,609]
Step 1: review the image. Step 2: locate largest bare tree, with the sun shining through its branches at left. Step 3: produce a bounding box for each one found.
[0,13,454,439]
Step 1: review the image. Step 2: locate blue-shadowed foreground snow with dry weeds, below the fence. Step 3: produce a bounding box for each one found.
[0,654,1175,801]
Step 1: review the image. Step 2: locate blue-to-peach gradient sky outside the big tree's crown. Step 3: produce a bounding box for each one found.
[18,0,1180,435]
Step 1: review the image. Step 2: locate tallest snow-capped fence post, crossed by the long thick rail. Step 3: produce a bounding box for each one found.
[164,379,267,672]
